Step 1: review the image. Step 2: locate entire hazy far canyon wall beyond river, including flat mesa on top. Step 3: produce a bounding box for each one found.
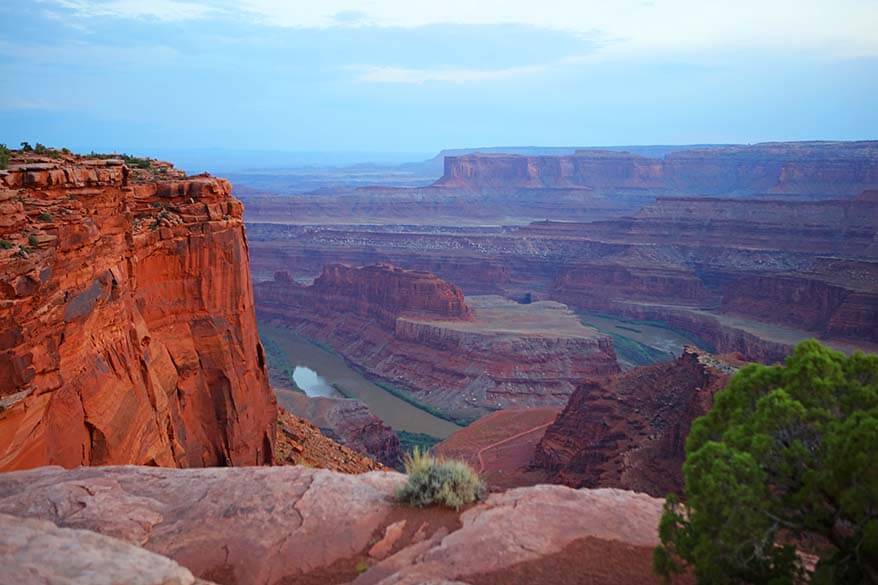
[245,142,878,362]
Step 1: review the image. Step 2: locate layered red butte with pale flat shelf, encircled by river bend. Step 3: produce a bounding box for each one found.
[255,265,618,417]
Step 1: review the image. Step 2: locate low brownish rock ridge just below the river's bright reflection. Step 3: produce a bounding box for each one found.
[278,392,403,468]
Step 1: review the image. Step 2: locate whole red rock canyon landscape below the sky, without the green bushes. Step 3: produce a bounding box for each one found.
[0,143,878,585]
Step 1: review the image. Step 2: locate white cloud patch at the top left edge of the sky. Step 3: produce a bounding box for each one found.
[39,0,222,21]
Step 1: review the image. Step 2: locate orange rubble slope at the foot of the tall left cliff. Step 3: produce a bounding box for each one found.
[274,410,384,473]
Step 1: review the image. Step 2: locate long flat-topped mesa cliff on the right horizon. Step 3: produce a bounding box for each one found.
[436,142,878,197]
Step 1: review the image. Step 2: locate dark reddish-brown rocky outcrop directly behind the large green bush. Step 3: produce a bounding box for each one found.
[534,348,734,495]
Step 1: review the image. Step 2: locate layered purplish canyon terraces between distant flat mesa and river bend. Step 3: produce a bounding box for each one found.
[250,191,878,362]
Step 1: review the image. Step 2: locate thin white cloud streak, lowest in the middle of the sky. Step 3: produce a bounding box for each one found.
[348,65,548,85]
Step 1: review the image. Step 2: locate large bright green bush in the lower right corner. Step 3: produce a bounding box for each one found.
[653,340,878,584]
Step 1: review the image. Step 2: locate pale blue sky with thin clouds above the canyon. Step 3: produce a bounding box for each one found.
[0,0,878,160]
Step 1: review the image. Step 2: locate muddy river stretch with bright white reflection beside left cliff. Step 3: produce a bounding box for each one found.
[259,323,461,438]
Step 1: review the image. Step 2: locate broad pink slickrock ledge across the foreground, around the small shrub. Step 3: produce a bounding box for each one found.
[0,466,680,585]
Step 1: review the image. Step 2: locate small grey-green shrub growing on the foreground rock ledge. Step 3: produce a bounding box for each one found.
[396,448,485,510]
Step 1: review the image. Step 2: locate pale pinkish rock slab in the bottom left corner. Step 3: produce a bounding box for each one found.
[0,514,210,585]
